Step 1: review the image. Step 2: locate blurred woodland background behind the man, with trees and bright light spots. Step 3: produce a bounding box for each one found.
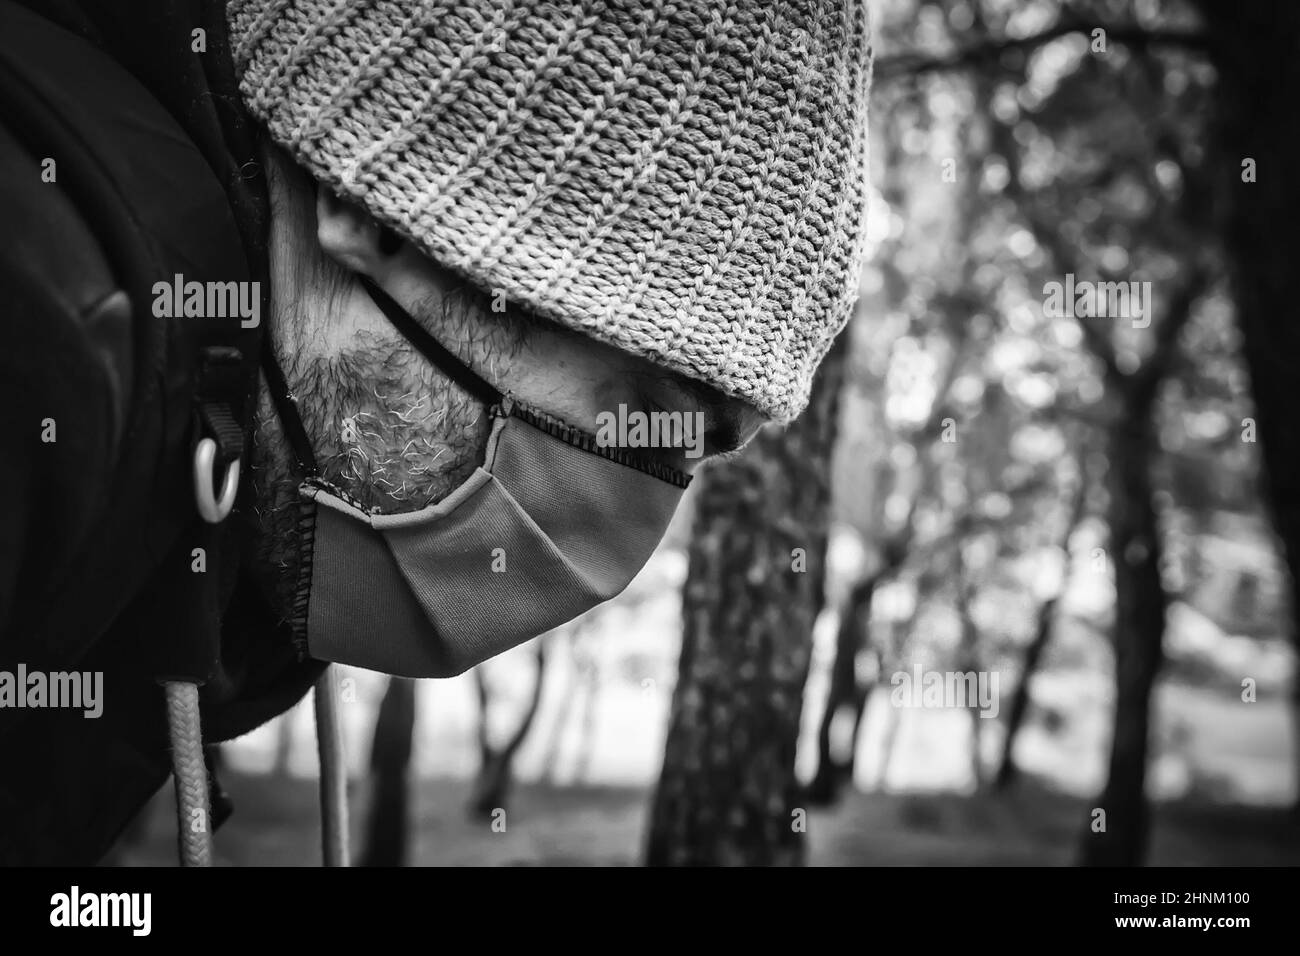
[113,0,1300,865]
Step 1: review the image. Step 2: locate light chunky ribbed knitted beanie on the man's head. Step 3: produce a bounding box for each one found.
[228,0,871,420]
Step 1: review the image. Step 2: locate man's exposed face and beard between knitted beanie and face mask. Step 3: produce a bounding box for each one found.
[245,151,764,609]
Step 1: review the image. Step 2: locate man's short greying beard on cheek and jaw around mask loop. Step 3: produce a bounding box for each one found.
[246,317,489,619]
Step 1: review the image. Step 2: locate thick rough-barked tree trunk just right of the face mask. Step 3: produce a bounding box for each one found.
[646,333,848,865]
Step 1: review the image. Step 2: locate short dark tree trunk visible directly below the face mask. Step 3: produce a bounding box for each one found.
[361,678,415,866]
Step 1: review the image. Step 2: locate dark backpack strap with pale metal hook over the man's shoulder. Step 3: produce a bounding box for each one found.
[0,0,257,684]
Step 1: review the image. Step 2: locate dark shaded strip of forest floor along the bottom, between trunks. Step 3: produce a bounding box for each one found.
[121,773,1300,866]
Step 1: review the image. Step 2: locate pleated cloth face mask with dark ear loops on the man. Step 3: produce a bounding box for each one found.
[263,277,690,678]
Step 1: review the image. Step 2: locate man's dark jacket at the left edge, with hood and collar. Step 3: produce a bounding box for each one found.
[0,0,322,865]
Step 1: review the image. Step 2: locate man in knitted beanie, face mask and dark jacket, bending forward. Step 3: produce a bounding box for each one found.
[0,0,870,862]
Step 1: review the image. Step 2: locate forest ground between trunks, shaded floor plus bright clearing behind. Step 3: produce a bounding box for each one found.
[109,551,1300,866]
